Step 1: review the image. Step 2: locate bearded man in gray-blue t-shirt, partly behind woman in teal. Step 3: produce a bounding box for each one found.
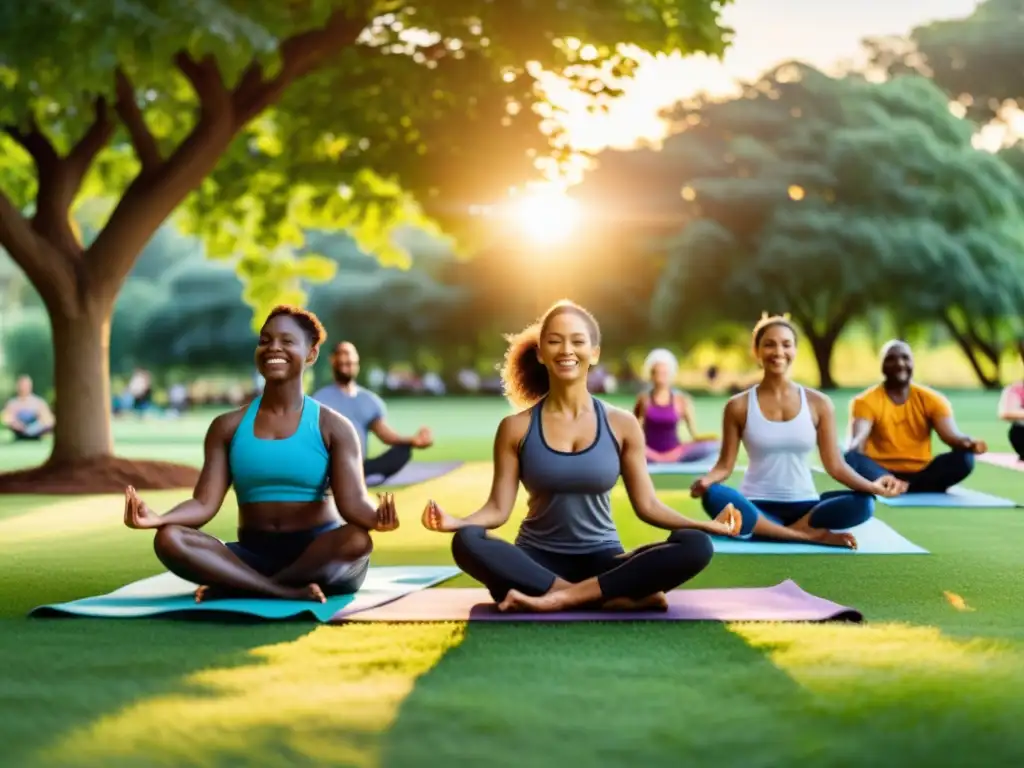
[313,341,433,485]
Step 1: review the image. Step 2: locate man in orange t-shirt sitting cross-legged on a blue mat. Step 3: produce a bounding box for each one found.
[846,341,988,494]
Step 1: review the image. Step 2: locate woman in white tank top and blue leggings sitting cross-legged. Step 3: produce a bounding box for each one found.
[690,315,906,549]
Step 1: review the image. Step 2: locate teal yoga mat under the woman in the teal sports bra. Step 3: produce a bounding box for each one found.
[29,565,460,622]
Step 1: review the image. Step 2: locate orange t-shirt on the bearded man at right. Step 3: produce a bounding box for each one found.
[850,384,953,472]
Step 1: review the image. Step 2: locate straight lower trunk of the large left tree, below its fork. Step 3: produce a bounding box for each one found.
[49,309,114,464]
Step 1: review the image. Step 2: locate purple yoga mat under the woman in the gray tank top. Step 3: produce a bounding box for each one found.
[335,580,864,622]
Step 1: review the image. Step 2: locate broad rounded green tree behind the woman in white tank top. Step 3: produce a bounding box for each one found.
[598,65,1024,387]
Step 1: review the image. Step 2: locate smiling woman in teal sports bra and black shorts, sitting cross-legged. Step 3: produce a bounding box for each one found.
[124,306,398,602]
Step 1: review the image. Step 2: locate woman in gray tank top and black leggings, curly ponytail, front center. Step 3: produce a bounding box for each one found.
[423,302,739,611]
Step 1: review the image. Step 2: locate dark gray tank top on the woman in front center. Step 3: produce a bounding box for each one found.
[516,398,622,554]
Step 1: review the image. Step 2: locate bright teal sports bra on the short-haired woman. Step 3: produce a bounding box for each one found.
[227,395,331,505]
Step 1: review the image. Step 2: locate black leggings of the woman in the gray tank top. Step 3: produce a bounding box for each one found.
[452,525,715,602]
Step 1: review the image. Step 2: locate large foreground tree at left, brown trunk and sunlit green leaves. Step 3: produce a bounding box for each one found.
[0,0,724,487]
